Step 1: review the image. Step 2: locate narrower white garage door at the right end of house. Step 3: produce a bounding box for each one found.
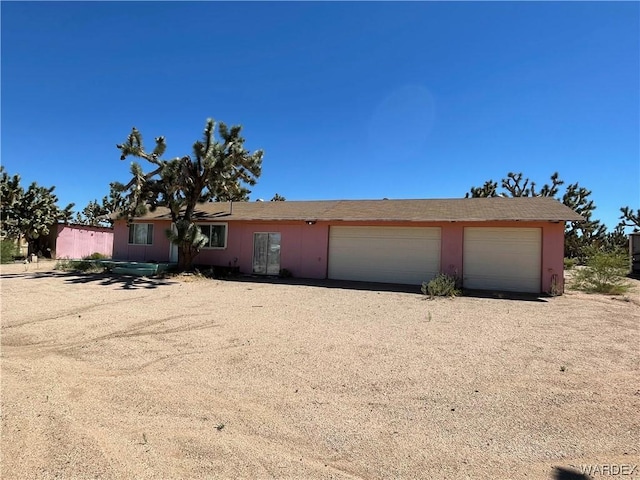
[462,227,542,293]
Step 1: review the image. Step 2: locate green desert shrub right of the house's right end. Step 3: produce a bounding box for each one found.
[573,250,630,295]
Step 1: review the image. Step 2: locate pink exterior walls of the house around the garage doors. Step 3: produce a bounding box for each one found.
[113,221,564,292]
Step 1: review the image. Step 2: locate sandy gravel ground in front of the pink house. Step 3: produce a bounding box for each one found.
[0,263,640,479]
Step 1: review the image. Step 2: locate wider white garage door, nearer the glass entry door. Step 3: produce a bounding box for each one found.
[329,227,440,285]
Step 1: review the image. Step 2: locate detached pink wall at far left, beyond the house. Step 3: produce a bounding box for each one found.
[55,225,114,259]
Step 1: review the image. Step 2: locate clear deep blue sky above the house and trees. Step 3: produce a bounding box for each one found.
[1,1,640,228]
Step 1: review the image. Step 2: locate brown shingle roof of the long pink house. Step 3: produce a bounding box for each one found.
[125,197,584,222]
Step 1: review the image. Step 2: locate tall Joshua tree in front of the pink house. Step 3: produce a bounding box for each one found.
[112,119,263,271]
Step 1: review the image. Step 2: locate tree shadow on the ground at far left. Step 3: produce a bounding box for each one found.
[0,271,178,290]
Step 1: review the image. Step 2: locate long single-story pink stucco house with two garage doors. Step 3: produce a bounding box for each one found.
[113,197,583,293]
